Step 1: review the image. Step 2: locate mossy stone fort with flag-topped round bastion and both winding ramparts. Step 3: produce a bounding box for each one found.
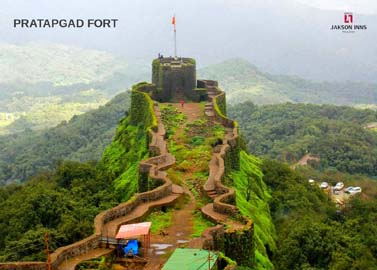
[0,57,255,270]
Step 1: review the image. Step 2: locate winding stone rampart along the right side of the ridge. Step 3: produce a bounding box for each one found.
[198,80,254,269]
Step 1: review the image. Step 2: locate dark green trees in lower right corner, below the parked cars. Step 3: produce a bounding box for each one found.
[262,161,377,270]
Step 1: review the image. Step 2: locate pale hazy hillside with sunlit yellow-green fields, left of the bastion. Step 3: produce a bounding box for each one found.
[0,43,146,135]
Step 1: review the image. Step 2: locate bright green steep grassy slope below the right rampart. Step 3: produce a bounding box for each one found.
[230,151,276,269]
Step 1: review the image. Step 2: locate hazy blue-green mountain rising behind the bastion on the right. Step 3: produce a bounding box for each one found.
[198,59,377,107]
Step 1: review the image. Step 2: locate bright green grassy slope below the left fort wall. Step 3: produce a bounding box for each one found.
[99,84,157,201]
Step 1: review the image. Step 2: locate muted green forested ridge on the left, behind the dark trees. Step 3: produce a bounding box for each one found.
[0,92,130,185]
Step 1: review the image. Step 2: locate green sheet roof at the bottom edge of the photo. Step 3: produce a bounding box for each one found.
[162,248,218,270]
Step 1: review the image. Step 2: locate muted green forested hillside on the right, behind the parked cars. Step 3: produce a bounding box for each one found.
[228,102,377,176]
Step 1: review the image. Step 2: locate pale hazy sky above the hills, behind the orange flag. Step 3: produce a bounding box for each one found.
[0,0,377,81]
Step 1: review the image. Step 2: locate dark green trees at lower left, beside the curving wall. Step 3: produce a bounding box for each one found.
[0,162,117,261]
